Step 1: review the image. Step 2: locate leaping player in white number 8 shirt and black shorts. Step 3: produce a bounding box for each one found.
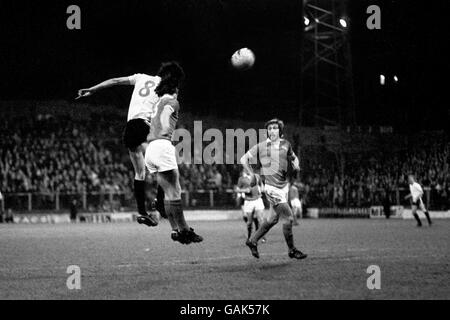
[77,64,171,227]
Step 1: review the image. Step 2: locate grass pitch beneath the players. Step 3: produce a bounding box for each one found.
[0,219,450,300]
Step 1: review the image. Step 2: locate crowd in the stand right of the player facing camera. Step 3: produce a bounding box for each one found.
[301,132,450,209]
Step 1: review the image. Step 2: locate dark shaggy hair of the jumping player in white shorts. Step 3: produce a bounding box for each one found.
[155,61,184,97]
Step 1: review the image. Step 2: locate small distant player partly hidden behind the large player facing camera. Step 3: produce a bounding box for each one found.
[236,170,265,239]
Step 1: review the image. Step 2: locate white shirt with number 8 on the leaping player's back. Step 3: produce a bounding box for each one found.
[127,73,161,121]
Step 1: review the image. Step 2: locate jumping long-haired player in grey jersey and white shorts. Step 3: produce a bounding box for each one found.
[145,62,203,244]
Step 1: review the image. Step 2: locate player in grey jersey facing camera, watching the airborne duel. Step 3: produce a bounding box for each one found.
[241,119,307,259]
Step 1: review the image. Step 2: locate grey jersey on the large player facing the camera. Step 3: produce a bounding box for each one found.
[248,139,296,188]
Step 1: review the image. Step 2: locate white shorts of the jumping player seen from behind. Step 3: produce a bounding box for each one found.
[145,139,178,173]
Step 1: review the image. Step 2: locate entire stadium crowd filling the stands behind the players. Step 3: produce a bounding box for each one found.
[0,114,450,208]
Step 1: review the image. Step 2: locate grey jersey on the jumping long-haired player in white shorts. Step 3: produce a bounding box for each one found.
[149,94,180,142]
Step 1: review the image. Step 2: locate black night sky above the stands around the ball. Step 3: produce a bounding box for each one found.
[0,0,449,126]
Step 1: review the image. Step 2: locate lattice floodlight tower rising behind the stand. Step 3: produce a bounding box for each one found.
[299,0,356,127]
